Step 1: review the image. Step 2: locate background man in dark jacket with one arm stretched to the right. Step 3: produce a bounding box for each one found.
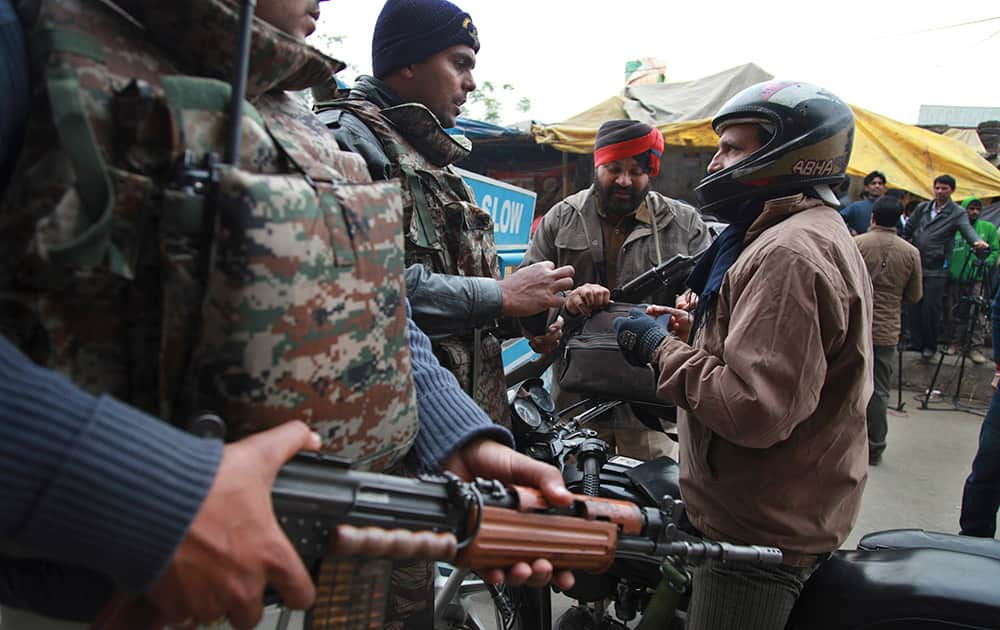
[903,175,989,361]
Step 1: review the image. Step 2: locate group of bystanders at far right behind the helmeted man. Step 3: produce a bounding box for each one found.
[840,171,1000,538]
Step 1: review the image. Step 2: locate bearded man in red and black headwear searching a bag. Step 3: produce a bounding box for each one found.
[521,120,711,460]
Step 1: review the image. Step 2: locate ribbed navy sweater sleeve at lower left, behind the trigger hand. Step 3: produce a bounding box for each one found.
[0,338,222,591]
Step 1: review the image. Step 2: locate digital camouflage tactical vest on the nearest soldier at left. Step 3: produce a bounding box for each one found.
[0,0,417,469]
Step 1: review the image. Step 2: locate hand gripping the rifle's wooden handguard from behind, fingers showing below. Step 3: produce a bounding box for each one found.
[445,439,574,590]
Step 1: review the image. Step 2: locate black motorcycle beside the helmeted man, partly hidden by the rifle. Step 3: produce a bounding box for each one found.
[504,379,1000,630]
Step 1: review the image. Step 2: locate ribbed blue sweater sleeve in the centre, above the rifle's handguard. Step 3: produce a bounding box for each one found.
[406,302,514,472]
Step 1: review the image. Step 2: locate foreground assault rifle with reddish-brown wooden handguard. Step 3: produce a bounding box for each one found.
[271,454,782,628]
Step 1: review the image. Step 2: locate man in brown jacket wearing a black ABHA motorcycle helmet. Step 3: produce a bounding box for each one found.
[616,81,872,630]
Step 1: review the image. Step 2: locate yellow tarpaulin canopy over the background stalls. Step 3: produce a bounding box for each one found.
[531,105,1000,199]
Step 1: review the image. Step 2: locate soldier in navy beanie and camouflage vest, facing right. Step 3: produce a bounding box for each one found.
[318,0,573,432]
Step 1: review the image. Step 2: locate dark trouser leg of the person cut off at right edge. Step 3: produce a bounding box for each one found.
[959,391,1000,538]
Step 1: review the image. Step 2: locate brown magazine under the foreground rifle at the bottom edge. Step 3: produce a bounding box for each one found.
[306,555,392,630]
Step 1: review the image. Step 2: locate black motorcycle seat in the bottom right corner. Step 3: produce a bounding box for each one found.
[786,549,1000,630]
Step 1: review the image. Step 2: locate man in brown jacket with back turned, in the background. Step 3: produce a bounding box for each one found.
[854,196,924,466]
